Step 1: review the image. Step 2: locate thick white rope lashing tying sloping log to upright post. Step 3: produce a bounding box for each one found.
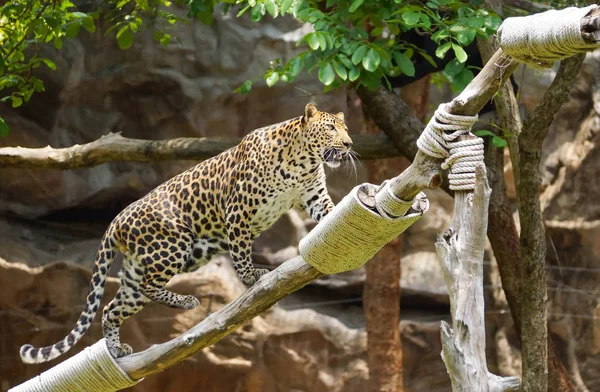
[417,104,484,191]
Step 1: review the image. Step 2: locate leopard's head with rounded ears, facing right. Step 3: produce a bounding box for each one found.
[302,103,352,167]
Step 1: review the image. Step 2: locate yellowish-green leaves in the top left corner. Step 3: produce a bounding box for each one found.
[0,0,177,136]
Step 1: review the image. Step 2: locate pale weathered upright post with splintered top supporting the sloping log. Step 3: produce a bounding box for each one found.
[436,165,519,392]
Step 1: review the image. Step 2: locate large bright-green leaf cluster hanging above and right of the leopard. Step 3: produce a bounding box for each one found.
[210,0,501,92]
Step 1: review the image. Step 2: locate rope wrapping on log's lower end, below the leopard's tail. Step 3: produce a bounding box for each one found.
[9,339,141,392]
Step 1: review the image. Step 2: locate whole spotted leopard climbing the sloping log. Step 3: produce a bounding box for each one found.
[20,103,355,363]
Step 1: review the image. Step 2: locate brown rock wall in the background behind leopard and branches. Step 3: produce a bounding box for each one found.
[0,5,600,392]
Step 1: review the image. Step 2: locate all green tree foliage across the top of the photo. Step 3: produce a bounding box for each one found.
[0,0,500,135]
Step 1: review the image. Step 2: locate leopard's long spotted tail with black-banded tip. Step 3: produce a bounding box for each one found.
[19,230,118,363]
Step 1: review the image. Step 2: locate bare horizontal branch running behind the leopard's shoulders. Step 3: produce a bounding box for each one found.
[0,133,401,170]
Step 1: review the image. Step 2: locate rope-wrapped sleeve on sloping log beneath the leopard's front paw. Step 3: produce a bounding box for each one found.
[300,183,429,274]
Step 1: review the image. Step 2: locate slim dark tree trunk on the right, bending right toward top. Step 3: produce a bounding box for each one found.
[517,54,585,392]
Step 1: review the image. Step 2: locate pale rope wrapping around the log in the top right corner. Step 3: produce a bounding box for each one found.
[498,4,599,68]
